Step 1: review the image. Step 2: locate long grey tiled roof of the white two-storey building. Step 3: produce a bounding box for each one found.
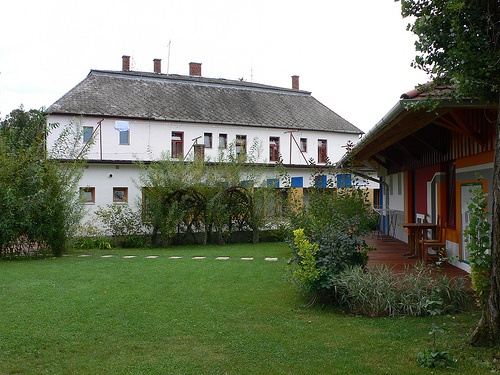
[47,70,362,134]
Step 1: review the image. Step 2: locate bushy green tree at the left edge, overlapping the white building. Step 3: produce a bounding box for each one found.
[0,108,89,256]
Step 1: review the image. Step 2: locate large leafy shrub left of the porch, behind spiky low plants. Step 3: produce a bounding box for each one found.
[290,172,378,301]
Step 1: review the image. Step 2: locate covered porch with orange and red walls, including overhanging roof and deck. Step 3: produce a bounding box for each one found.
[338,84,498,274]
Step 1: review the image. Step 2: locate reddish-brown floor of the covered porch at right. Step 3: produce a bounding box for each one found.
[366,234,469,276]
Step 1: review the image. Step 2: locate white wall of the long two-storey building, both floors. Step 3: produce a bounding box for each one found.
[47,115,378,226]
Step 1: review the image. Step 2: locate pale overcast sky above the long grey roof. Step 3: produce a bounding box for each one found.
[0,0,427,132]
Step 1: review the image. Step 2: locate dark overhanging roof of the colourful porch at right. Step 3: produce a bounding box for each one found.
[338,87,497,175]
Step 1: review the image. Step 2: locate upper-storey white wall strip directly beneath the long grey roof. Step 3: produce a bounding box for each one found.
[48,116,358,165]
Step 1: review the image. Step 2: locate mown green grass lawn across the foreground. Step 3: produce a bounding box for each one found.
[0,243,493,374]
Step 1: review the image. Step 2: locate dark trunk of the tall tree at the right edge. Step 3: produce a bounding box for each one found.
[468,99,500,346]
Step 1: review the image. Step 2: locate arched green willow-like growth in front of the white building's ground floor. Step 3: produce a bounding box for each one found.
[140,138,284,244]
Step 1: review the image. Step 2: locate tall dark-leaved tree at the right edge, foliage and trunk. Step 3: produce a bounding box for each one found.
[395,0,500,346]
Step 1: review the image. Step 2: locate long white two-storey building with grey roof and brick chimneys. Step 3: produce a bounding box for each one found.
[47,56,370,222]
